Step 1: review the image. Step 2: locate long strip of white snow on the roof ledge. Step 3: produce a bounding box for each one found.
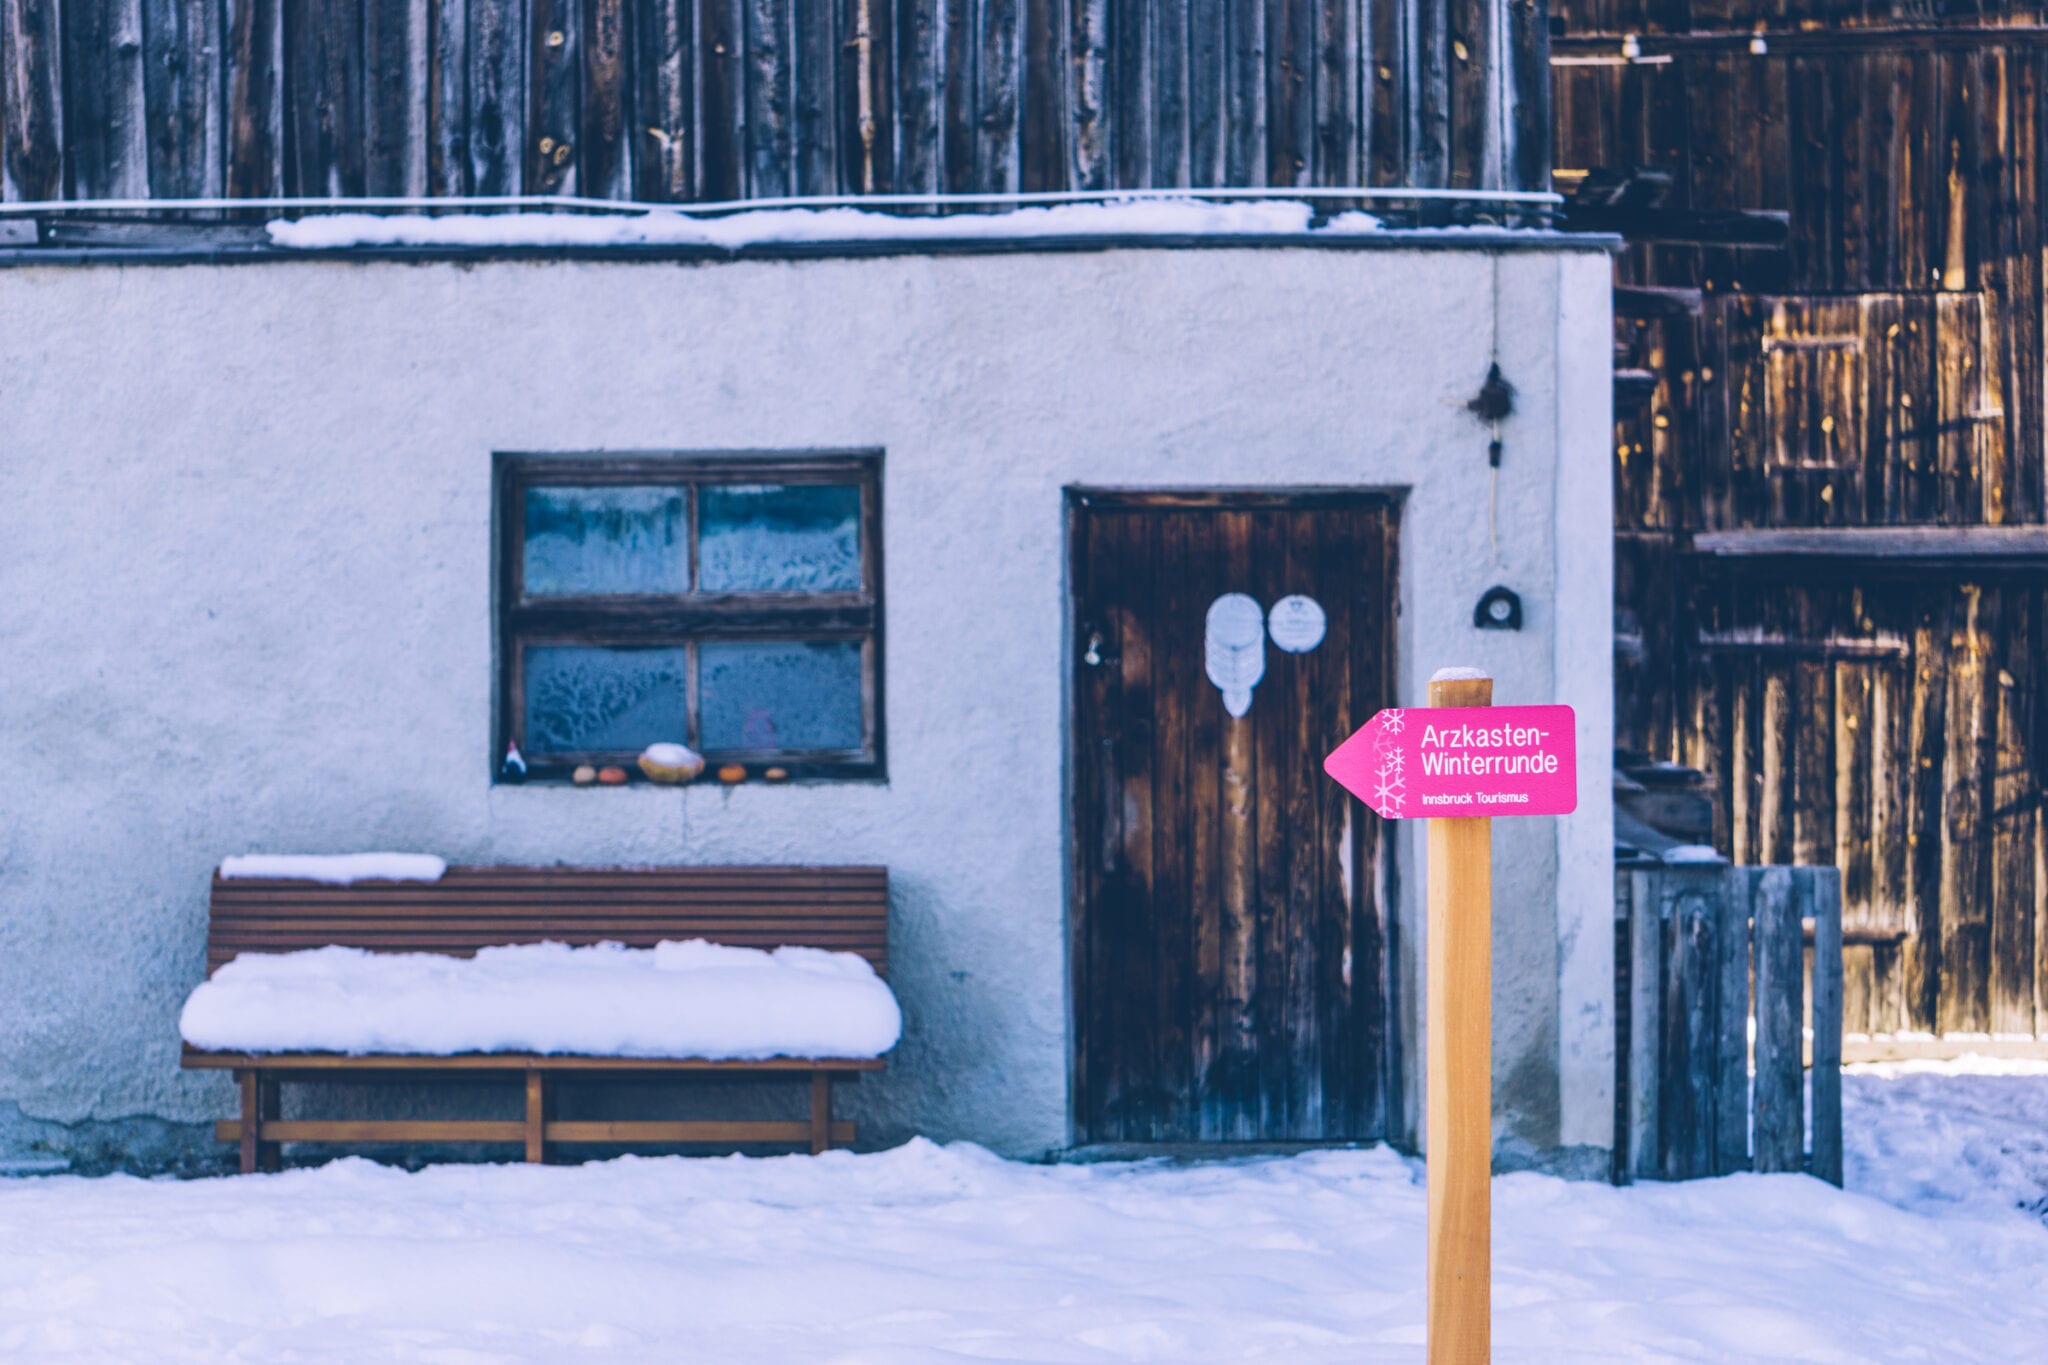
[266,199,1382,250]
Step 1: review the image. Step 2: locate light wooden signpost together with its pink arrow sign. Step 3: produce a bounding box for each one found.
[1323,669,1579,1365]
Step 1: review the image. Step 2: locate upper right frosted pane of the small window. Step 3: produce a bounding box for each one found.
[696,483,860,591]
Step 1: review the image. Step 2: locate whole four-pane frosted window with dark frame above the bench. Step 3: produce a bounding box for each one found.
[496,454,883,778]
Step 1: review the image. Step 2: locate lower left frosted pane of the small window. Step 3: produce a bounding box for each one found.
[526,645,690,755]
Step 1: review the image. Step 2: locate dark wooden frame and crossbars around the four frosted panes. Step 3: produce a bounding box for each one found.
[492,450,887,780]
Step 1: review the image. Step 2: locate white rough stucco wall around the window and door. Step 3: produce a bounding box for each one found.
[0,246,1612,1156]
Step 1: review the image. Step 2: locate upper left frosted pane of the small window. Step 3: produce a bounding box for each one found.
[524,485,690,598]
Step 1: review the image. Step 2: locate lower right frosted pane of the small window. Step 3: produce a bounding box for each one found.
[696,641,862,749]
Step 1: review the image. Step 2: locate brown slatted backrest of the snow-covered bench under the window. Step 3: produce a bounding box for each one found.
[207,868,889,976]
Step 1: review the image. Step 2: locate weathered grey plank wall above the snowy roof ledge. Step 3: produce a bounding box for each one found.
[0,0,1548,201]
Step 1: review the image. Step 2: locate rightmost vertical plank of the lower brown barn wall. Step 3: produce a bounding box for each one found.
[1987,587,2042,1036]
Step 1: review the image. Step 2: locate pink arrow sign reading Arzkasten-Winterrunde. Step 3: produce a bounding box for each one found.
[1323,706,1579,821]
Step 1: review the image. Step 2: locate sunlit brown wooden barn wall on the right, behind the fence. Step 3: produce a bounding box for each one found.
[1554,10,2048,1036]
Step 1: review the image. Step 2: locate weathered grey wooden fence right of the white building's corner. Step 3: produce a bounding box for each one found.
[1614,864,1841,1185]
